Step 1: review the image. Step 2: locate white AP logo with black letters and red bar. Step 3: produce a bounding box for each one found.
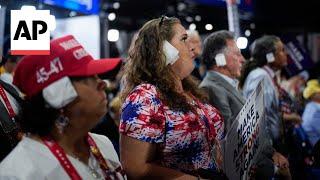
[11,8,56,55]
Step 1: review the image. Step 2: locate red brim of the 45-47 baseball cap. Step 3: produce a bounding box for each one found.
[68,58,121,76]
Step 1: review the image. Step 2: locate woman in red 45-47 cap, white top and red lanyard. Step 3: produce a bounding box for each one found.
[0,36,126,180]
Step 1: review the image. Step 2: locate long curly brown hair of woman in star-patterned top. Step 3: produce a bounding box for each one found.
[121,17,205,112]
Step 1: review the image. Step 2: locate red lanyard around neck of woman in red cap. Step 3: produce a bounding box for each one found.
[42,134,123,180]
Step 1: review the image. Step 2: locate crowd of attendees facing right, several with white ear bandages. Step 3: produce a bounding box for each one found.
[0,16,320,180]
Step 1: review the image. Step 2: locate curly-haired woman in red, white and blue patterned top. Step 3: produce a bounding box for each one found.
[120,16,224,179]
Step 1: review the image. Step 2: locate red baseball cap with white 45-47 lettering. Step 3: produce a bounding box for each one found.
[13,35,121,97]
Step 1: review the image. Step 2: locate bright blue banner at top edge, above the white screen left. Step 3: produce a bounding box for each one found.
[40,0,99,14]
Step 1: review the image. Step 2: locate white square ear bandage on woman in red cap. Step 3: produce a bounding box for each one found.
[42,77,78,109]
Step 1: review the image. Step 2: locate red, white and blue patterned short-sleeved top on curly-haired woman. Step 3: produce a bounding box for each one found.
[120,84,224,174]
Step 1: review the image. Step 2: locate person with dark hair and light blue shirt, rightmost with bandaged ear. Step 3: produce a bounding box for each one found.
[239,35,292,178]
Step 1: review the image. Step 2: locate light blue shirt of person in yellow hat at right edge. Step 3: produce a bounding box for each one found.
[302,102,320,146]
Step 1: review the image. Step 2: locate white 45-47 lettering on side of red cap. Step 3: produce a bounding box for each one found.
[36,58,63,83]
